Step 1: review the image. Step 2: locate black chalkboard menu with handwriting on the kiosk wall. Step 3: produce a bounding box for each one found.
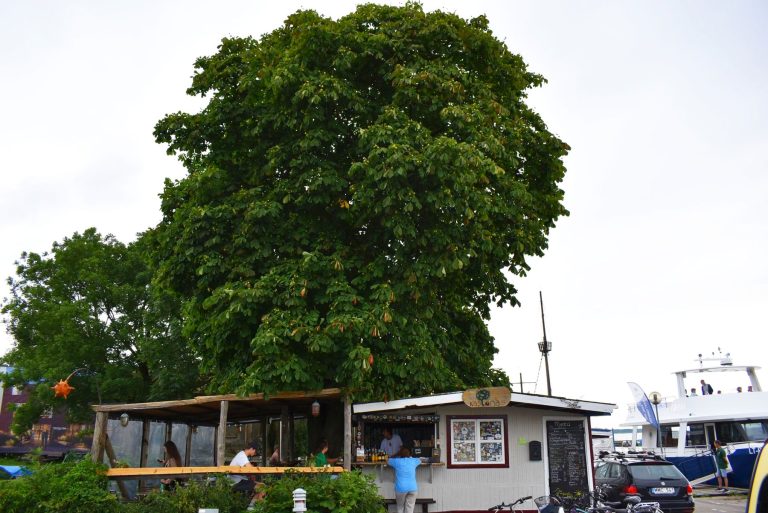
[547,420,589,495]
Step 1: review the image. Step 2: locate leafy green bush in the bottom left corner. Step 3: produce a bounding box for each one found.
[0,460,120,513]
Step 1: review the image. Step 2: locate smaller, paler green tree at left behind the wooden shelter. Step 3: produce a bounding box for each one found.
[2,228,199,432]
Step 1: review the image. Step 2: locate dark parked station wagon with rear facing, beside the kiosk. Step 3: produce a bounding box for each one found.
[595,453,695,513]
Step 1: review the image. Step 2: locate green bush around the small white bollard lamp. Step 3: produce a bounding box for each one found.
[255,472,385,513]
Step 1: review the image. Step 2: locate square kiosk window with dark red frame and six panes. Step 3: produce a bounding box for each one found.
[448,416,509,467]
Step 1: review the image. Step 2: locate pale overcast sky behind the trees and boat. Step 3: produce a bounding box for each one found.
[0,0,768,425]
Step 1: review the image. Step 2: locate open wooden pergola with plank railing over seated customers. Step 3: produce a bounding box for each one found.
[91,388,352,494]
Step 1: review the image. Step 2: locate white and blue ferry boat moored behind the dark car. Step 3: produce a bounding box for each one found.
[622,354,768,488]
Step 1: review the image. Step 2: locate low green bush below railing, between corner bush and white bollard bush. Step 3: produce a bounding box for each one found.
[120,479,248,513]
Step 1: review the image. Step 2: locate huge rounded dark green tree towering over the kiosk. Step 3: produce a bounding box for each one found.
[155,3,568,398]
